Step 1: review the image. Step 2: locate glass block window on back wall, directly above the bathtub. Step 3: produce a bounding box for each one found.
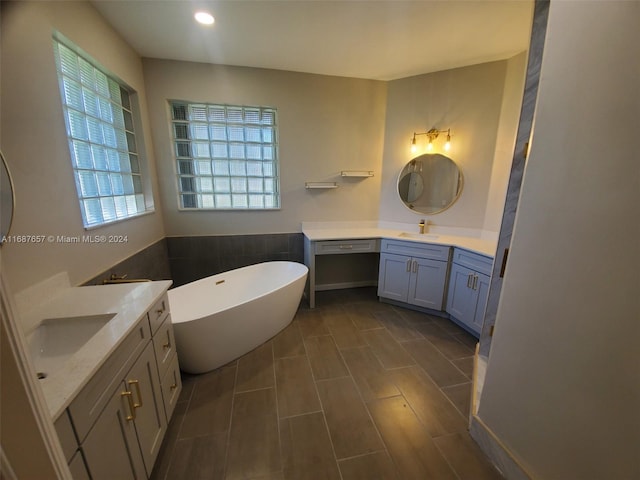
[171,101,280,210]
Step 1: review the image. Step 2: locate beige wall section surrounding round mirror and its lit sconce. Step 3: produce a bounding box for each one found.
[380,55,524,231]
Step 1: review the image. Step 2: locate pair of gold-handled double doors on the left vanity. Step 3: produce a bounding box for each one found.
[82,343,167,480]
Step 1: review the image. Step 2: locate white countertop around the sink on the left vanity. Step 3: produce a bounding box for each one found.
[25,280,171,421]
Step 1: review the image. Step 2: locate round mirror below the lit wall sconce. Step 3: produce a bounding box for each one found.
[398,153,462,215]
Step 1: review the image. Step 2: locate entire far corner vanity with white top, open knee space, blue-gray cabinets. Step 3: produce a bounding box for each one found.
[302,223,496,336]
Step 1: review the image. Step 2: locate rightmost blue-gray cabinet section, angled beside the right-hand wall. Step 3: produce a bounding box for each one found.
[447,248,493,336]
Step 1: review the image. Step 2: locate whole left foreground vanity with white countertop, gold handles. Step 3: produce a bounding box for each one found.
[21,281,182,480]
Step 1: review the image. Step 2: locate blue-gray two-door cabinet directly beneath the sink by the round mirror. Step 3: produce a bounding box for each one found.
[378,239,450,311]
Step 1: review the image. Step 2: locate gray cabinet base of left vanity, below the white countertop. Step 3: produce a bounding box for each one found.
[56,294,182,480]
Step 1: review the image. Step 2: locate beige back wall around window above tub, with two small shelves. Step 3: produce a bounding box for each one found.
[144,59,387,236]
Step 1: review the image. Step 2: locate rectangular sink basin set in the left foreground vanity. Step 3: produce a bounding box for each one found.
[27,313,116,379]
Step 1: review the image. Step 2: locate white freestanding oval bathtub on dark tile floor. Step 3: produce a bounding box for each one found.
[169,262,308,373]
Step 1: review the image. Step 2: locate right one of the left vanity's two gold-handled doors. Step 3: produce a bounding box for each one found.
[125,342,167,475]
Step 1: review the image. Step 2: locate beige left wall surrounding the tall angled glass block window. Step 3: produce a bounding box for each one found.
[0,1,164,293]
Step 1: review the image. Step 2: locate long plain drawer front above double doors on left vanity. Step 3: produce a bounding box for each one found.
[69,319,151,443]
